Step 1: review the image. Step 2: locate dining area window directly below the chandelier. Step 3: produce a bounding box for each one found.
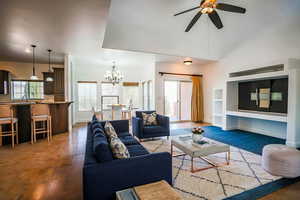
[101,82,119,110]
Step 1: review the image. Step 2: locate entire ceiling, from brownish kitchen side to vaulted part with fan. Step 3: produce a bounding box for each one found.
[0,0,300,63]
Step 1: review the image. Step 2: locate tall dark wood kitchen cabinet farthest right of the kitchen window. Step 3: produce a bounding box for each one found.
[54,68,65,101]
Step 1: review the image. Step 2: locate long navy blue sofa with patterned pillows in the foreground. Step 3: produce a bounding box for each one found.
[83,120,172,200]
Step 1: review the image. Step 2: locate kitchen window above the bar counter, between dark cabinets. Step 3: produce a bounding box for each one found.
[11,80,44,100]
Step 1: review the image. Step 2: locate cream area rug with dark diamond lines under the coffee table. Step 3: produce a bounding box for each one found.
[142,139,281,200]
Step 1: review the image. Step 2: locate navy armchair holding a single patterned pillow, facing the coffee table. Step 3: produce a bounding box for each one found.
[132,111,170,139]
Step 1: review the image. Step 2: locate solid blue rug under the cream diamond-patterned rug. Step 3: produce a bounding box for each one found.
[171,126,300,200]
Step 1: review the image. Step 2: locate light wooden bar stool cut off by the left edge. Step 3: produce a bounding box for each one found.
[0,105,19,148]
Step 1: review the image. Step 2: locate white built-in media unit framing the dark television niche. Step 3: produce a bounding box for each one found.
[224,59,300,147]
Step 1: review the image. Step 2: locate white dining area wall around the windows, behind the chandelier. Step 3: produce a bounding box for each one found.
[72,56,155,123]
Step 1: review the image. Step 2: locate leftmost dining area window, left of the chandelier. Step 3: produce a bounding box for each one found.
[78,82,97,111]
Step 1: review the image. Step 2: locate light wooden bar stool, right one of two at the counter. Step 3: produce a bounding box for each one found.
[30,104,52,144]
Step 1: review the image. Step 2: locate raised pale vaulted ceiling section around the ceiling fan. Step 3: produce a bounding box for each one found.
[103,0,300,60]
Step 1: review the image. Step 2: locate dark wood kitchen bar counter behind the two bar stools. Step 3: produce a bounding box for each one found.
[0,101,73,146]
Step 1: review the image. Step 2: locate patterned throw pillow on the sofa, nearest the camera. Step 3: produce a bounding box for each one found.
[110,137,130,159]
